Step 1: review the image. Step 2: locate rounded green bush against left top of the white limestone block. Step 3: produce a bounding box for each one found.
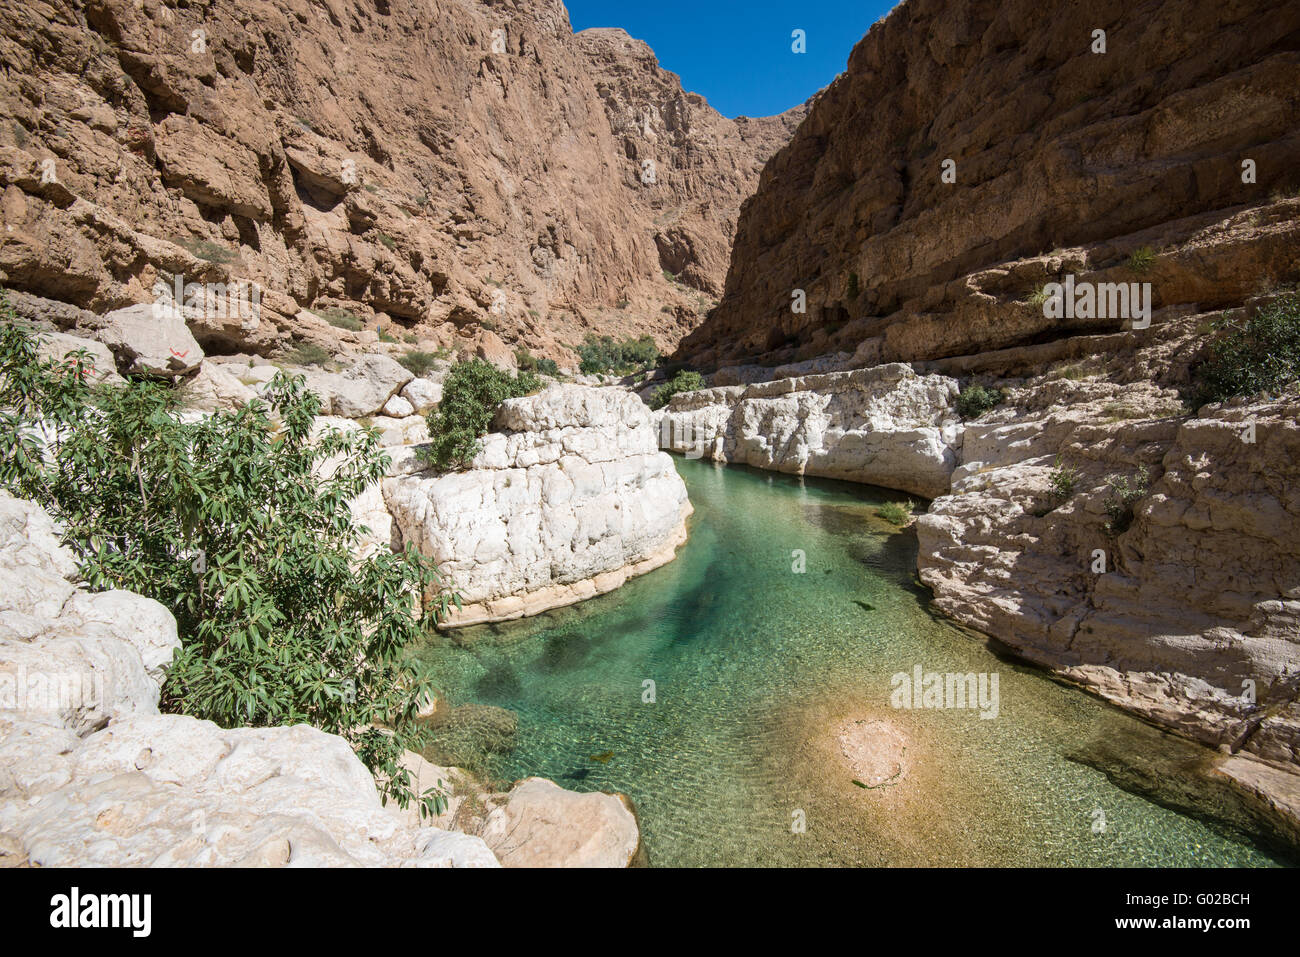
[421,359,542,469]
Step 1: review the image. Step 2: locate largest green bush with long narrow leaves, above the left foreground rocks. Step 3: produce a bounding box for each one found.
[0,313,459,810]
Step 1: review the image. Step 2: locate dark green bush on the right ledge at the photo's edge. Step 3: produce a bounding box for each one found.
[1192,295,1300,404]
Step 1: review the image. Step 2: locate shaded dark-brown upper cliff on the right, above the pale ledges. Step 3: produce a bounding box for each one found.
[680,0,1300,367]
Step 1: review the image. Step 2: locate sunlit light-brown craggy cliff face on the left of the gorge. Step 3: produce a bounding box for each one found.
[0,0,802,361]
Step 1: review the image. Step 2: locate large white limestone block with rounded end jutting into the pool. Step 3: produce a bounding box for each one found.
[384,385,690,625]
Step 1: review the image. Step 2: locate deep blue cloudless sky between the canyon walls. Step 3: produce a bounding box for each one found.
[564,0,896,117]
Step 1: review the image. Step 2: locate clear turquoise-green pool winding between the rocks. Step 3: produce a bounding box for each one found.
[421,459,1277,866]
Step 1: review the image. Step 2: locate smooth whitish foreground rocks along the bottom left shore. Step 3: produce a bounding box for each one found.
[0,492,640,867]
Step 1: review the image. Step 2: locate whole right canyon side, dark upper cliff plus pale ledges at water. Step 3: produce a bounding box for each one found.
[664,0,1300,800]
